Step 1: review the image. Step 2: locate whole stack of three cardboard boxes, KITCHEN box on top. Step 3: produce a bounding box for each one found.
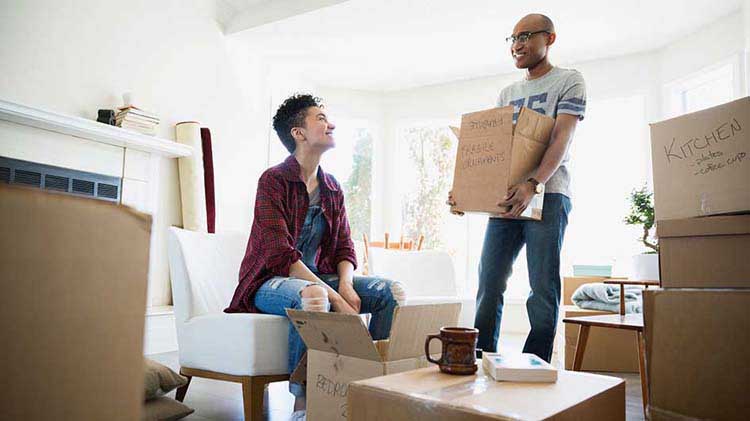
[644,98,750,420]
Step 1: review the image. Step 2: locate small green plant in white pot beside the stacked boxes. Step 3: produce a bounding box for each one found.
[624,185,659,281]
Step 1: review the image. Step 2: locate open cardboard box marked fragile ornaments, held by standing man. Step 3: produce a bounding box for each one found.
[452,106,555,220]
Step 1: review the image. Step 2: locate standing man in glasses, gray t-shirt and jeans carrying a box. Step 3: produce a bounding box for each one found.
[449,14,586,361]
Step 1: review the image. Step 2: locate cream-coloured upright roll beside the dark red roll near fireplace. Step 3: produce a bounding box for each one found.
[175,121,208,232]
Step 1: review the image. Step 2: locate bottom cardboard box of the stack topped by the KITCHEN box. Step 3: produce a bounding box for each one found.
[643,289,750,421]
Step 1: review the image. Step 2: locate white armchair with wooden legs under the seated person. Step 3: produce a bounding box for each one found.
[168,227,289,420]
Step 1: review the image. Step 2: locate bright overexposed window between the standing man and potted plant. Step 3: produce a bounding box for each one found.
[561,94,651,284]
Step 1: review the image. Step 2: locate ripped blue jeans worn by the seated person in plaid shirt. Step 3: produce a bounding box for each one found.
[255,275,397,397]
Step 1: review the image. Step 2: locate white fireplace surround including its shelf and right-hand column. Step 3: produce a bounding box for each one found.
[0,99,193,352]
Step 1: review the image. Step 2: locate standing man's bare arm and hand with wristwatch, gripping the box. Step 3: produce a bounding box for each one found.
[506,114,579,217]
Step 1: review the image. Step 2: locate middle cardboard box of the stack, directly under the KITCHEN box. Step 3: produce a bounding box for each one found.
[656,215,750,288]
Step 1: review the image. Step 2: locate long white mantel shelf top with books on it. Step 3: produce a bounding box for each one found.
[0,99,193,158]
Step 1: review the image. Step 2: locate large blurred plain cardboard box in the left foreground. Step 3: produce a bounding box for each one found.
[0,184,151,421]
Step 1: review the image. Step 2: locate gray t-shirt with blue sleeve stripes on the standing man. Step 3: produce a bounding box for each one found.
[497,67,586,197]
